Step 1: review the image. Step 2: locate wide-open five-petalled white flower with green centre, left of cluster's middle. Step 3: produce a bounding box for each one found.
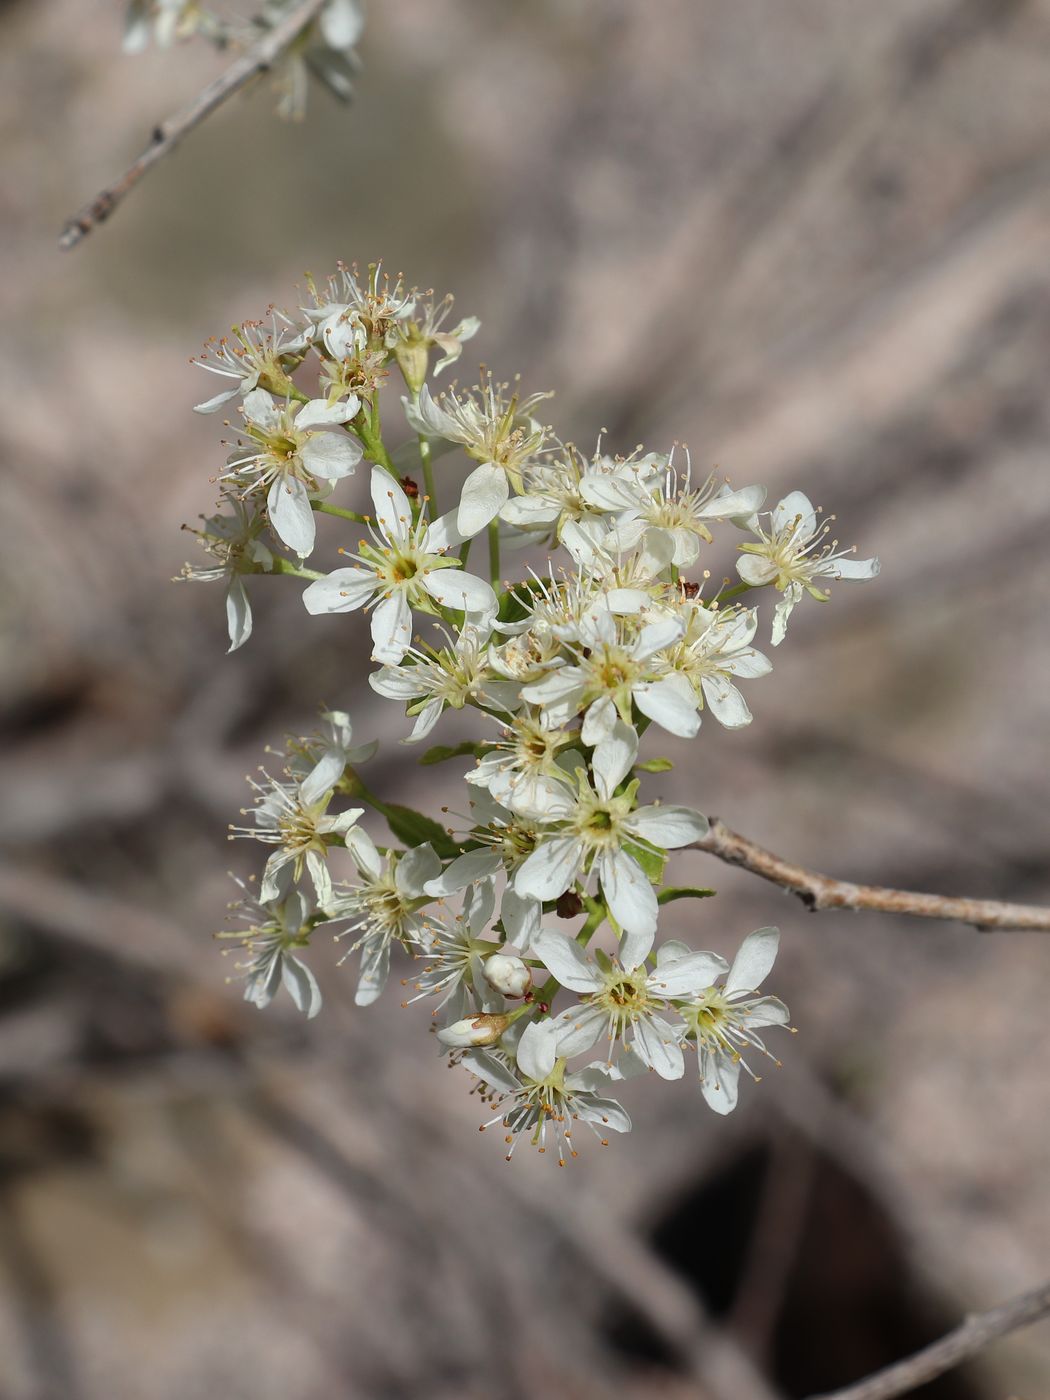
[302,466,497,665]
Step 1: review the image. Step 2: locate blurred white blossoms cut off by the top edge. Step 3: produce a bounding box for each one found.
[123,0,364,119]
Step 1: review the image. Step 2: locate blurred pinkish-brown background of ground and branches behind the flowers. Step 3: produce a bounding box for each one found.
[0,0,1050,1400]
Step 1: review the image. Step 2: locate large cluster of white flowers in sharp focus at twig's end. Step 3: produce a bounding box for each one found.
[186,266,878,1162]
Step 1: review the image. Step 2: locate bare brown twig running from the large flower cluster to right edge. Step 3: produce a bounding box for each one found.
[690,816,1050,934]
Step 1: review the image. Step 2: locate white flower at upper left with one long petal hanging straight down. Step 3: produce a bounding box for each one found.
[224,389,363,559]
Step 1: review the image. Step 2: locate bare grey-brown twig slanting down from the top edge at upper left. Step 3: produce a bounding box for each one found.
[59,0,323,249]
